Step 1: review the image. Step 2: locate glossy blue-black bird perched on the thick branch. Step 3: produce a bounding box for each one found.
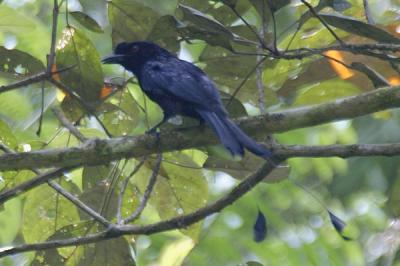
[103,41,271,158]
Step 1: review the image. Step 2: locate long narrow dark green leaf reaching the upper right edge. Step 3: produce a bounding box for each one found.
[319,13,400,44]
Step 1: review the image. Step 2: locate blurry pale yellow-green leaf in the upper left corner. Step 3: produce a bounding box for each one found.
[0,5,36,33]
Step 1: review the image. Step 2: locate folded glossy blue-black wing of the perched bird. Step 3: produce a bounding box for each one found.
[140,58,225,113]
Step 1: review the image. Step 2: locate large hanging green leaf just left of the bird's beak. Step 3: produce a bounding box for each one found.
[56,27,103,105]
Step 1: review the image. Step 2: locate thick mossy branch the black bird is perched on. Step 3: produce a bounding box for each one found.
[0,86,400,171]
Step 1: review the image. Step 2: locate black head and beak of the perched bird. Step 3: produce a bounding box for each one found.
[102,41,171,73]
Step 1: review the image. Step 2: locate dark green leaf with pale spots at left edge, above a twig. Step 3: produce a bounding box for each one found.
[0,46,45,76]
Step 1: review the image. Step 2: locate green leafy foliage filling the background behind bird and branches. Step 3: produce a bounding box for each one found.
[0,0,400,265]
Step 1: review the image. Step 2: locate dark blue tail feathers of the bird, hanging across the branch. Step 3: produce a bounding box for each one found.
[198,110,272,158]
